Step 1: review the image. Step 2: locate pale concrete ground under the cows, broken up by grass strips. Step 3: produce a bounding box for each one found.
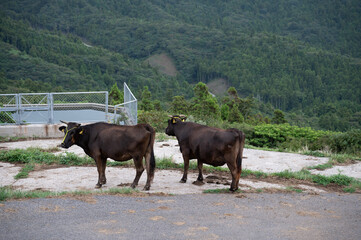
[0,139,361,194]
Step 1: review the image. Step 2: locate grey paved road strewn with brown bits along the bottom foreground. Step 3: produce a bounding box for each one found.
[0,193,361,240]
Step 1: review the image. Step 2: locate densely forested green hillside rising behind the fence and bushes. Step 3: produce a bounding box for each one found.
[0,0,361,131]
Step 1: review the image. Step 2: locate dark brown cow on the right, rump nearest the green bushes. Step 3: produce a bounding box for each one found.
[165,115,245,191]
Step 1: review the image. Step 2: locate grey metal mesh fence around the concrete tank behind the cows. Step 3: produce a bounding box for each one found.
[0,83,137,125]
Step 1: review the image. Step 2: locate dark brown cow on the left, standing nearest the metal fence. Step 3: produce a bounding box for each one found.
[59,121,155,190]
